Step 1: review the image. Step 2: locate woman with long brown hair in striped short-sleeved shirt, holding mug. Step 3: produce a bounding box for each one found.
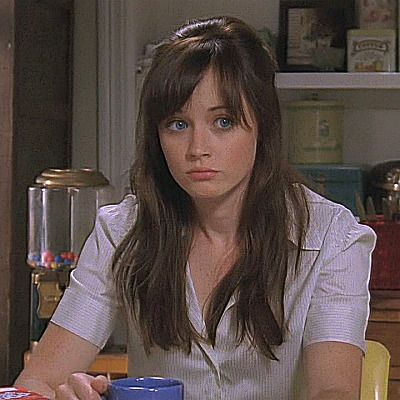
[16,17,375,400]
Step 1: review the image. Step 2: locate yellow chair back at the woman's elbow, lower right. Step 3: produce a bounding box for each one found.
[360,340,390,400]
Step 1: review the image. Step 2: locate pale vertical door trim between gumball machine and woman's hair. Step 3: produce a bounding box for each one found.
[97,0,136,198]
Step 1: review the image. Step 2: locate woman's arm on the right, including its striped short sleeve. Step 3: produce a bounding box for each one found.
[303,211,375,400]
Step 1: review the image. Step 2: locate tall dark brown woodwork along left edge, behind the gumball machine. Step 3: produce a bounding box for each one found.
[0,0,73,385]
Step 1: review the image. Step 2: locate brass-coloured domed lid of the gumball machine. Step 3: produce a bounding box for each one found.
[35,168,109,187]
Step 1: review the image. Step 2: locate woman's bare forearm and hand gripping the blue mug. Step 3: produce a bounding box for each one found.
[15,323,107,399]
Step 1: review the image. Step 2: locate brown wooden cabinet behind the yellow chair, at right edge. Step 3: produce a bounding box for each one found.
[367,290,400,400]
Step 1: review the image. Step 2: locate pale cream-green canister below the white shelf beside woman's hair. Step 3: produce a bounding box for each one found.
[287,100,343,164]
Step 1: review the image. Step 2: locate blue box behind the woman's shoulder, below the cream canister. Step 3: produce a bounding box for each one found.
[294,164,367,215]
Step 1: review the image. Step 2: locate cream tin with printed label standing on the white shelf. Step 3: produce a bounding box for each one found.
[347,29,396,72]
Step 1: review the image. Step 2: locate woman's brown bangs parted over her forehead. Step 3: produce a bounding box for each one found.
[144,37,249,127]
